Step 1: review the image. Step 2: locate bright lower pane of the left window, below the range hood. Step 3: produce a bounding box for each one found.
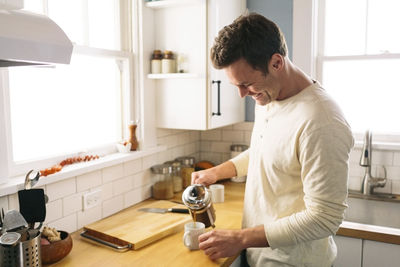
[9,55,122,162]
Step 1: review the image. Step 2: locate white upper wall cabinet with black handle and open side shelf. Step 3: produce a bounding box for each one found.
[140,0,246,130]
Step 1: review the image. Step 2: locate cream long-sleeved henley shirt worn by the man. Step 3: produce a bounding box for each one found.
[231,82,354,267]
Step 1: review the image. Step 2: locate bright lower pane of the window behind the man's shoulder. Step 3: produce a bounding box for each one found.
[323,59,400,133]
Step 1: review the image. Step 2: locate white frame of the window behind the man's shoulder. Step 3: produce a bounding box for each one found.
[293,0,400,150]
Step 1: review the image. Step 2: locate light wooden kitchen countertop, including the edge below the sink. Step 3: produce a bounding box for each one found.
[49,181,400,267]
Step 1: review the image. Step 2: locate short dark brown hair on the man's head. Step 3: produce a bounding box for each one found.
[211,13,287,74]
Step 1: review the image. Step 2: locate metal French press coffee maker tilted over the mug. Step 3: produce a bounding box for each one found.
[182,184,216,228]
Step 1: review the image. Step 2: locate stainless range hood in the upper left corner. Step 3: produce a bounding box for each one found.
[0,10,73,67]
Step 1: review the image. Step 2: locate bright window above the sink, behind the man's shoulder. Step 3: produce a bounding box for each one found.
[316,0,400,141]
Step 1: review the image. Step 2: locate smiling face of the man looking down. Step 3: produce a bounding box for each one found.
[225,59,280,106]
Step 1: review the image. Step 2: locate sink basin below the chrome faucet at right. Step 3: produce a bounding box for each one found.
[344,193,400,228]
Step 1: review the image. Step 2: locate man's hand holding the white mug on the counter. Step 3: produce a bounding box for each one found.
[199,230,245,260]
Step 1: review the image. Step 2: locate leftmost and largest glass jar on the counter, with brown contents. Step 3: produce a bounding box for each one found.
[151,164,174,199]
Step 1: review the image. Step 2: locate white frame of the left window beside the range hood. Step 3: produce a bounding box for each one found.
[0,0,145,180]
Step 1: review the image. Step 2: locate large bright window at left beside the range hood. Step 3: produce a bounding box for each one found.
[0,0,134,179]
